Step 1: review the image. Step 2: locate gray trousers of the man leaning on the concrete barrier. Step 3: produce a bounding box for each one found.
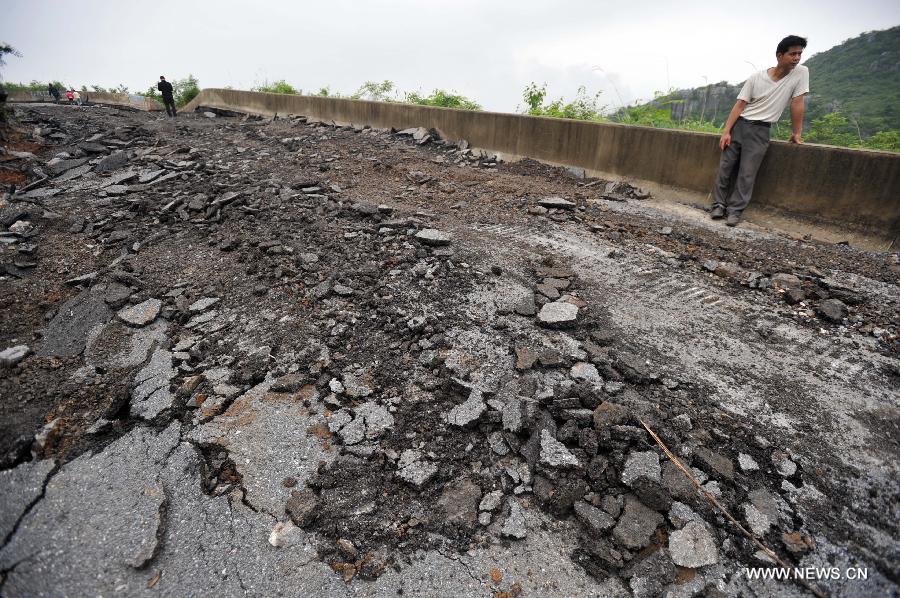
[713,119,769,214]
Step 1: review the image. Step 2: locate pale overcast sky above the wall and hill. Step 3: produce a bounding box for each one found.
[0,0,900,111]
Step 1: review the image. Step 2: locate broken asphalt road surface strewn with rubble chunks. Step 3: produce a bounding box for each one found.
[0,106,900,597]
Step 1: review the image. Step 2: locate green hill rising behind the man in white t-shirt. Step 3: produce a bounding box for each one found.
[640,26,900,137]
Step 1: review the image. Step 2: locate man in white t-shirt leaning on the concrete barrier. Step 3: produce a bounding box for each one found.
[710,35,809,226]
